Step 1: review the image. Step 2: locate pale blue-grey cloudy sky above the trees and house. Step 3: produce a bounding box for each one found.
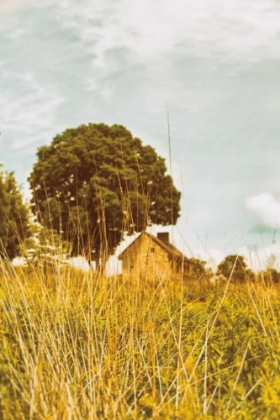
[0,0,280,269]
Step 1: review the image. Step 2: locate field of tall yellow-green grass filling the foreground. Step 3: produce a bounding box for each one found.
[0,264,280,420]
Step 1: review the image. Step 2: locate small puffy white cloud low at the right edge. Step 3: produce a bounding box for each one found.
[245,193,280,228]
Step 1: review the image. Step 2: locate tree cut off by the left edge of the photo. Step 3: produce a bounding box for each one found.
[0,166,29,259]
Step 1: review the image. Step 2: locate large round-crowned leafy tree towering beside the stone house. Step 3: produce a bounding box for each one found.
[29,124,181,262]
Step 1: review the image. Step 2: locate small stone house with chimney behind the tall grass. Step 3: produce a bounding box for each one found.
[118,232,190,279]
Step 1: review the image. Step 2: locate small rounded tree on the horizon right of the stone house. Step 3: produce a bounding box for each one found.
[217,255,253,283]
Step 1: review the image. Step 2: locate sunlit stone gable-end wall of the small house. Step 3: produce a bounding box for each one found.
[123,234,171,279]
